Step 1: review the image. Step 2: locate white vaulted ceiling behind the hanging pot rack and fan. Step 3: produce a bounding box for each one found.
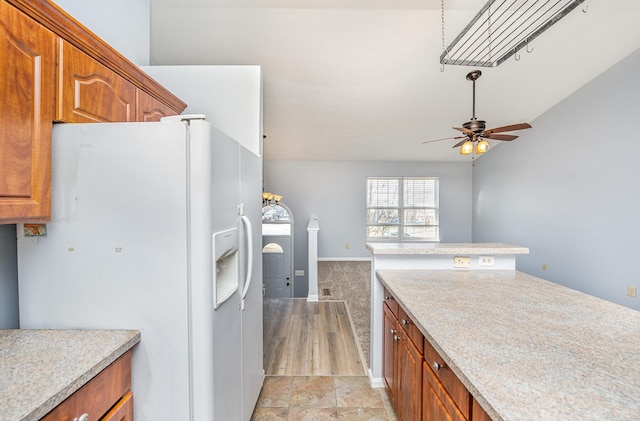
[151,0,640,161]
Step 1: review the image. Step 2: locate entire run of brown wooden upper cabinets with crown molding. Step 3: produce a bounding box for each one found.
[0,0,186,224]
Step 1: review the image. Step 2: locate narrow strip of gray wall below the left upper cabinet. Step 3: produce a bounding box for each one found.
[0,225,19,329]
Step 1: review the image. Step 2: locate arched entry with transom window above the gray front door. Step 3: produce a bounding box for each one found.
[262,203,294,298]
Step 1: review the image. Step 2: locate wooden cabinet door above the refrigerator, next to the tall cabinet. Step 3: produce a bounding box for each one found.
[56,41,136,123]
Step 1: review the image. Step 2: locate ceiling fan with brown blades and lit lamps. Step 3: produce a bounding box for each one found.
[422,70,531,155]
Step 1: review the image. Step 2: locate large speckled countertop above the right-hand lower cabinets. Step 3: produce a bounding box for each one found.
[376,270,640,421]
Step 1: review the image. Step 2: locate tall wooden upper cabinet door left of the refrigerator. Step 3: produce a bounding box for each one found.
[0,1,56,223]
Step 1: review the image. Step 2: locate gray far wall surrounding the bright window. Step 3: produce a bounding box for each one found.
[264,160,472,297]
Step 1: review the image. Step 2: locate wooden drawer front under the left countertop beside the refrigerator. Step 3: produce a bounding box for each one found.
[41,351,133,421]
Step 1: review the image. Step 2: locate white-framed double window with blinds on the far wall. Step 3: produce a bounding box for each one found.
[367,177,440,241]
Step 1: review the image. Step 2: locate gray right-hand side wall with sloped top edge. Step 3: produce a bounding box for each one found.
[473,50,640,310]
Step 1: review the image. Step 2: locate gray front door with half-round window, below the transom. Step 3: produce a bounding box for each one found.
[262,236,293,298]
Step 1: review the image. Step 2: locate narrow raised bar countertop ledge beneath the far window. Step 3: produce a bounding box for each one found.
[365,242,529,255]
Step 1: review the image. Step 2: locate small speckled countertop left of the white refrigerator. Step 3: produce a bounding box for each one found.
[0,329,140,421]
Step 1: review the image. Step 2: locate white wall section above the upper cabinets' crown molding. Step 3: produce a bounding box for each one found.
[55,0,151,66]
